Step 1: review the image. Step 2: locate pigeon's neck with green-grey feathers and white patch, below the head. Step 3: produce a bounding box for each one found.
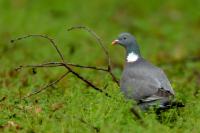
[126,46,141,62]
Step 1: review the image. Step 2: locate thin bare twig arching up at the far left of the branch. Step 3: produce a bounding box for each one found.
[10,34,64,62]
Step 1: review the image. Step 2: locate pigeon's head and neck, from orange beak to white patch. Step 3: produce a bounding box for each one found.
[112,33,141,62]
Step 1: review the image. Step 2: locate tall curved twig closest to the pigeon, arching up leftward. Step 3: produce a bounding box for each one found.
[67,26,119,86]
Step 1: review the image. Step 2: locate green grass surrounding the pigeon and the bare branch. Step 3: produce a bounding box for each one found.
[0,0,200,133]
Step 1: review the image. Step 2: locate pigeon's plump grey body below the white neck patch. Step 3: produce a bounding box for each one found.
[120,58,174,102]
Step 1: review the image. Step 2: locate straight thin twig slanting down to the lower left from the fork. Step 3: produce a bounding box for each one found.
[23,71,70,99]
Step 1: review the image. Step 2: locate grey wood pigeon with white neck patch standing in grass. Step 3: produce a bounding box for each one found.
[112,33,175,110]
